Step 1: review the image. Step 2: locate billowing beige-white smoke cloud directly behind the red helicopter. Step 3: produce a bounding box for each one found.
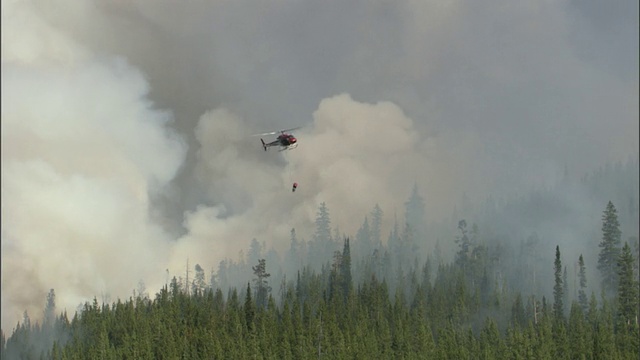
[165,94,436,271]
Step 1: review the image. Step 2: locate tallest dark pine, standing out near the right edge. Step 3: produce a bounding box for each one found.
[598,201,622,296]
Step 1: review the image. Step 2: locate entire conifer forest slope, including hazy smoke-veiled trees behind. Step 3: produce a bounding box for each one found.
[0,158,640,359]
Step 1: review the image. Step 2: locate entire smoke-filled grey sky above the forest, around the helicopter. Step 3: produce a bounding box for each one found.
[1,0,639,331]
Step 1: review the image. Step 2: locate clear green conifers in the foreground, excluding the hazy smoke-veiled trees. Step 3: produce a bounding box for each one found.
[1,203,640,360]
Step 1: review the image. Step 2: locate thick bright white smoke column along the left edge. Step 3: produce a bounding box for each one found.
[2,1,185,329]
